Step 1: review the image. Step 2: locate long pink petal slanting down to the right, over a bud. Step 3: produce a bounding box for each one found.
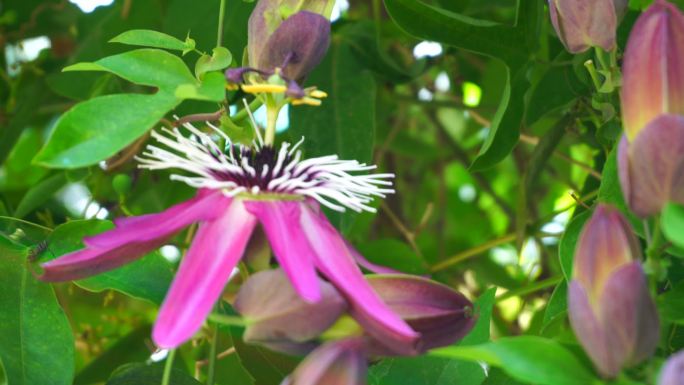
[301,203,419,354]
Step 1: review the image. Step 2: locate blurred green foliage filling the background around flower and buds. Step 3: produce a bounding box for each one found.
[0,0,684,385]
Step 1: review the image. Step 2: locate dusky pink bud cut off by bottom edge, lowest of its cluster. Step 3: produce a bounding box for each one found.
[281,338,368,385]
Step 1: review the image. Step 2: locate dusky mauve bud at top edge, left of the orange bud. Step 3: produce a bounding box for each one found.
[549,0,624,53]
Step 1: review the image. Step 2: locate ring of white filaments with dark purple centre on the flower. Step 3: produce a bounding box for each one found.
[138,124,394,211]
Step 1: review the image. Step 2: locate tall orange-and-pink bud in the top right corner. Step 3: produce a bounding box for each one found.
[621,0,684,142]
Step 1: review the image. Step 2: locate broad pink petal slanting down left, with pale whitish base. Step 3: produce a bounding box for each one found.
[152,199,256,348]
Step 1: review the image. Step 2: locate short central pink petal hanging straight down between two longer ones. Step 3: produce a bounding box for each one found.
[245,201,321,303]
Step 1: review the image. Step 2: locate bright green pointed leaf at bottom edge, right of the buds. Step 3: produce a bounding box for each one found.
[431,336,598,385]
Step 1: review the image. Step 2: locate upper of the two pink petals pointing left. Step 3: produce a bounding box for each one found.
[83,191,230,248]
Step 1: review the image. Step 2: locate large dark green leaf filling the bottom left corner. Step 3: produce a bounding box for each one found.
[0,237,74,385]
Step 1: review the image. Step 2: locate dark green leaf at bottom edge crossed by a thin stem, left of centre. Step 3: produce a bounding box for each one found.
[106,364,202,385]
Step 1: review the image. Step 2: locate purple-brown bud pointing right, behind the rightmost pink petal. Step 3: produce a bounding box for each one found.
[368,274,475,356]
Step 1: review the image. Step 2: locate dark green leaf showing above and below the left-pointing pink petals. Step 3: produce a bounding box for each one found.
[43,220,173,305]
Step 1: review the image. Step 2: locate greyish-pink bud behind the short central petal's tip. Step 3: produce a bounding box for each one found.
[234,269,347,354]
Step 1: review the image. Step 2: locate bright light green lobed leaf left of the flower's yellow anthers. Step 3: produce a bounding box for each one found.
[34,49,206,168]
